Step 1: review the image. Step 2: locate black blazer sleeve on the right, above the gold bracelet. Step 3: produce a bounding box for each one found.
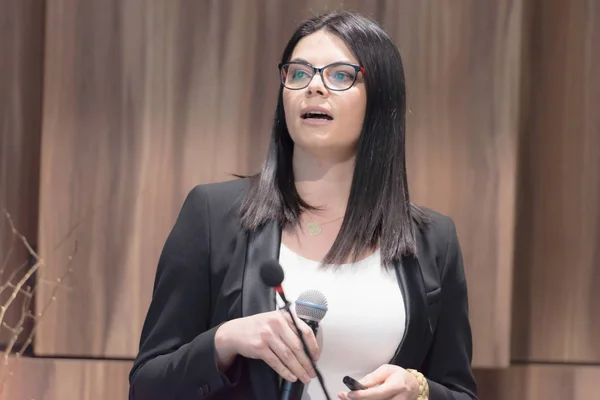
[423,218,477,400]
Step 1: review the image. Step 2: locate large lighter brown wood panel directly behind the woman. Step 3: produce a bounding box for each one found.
[36,0,521,366]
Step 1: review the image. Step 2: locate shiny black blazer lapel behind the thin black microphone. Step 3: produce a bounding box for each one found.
[242,222,281,400]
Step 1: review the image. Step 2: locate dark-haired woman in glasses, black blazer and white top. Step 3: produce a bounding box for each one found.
[130,12,476,400]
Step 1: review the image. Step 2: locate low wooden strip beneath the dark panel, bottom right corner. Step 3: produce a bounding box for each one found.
[475,365,600,400]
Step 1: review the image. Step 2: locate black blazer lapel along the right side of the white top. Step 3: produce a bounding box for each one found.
[392,253,430,368]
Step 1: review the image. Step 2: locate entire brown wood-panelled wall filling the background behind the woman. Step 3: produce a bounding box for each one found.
[0,0,600,400]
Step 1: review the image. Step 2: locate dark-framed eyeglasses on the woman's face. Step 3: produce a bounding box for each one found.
[278,62,365,91]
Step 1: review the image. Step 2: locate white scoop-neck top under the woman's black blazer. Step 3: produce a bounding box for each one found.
[279,244,406,400]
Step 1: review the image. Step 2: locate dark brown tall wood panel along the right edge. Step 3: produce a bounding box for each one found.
[513,0,600,363]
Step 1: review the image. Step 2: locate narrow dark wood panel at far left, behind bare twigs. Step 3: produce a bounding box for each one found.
[0,0,44,345]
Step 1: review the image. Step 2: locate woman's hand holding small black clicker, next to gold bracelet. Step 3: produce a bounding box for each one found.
[338,364,419,400]
